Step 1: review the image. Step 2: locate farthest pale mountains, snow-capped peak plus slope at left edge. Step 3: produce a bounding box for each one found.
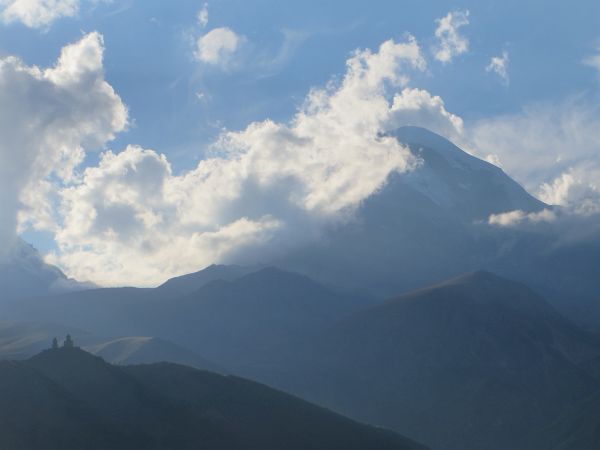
[0,127,600,331]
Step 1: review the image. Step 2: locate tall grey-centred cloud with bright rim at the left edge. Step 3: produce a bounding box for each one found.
[0,33,127,255]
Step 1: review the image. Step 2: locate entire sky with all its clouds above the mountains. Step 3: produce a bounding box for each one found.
[0,0,600,285]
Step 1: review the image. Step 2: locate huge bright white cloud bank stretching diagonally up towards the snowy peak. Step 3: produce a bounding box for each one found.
[51,37,434,285]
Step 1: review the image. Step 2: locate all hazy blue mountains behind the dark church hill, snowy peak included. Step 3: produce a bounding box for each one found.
[0,127,600,450]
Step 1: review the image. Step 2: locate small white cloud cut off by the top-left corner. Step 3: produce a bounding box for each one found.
[0,0,79,28]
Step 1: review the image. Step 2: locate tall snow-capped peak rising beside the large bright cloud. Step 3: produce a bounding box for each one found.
[273,127,546,297]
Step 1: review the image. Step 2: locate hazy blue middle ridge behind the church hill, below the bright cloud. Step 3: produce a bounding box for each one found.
[6,268,371,370]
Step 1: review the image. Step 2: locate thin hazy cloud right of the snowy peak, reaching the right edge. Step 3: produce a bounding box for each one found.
[467,97,600,211]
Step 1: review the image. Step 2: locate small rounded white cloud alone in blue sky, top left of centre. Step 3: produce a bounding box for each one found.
[194,27,246,67]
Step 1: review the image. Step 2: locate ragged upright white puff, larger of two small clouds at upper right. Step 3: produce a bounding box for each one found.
[433,10,469,63]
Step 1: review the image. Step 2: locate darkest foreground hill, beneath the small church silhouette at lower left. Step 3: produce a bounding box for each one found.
[0,348,422,450]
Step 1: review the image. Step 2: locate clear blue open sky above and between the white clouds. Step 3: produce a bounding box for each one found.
[0,0,600,170]
